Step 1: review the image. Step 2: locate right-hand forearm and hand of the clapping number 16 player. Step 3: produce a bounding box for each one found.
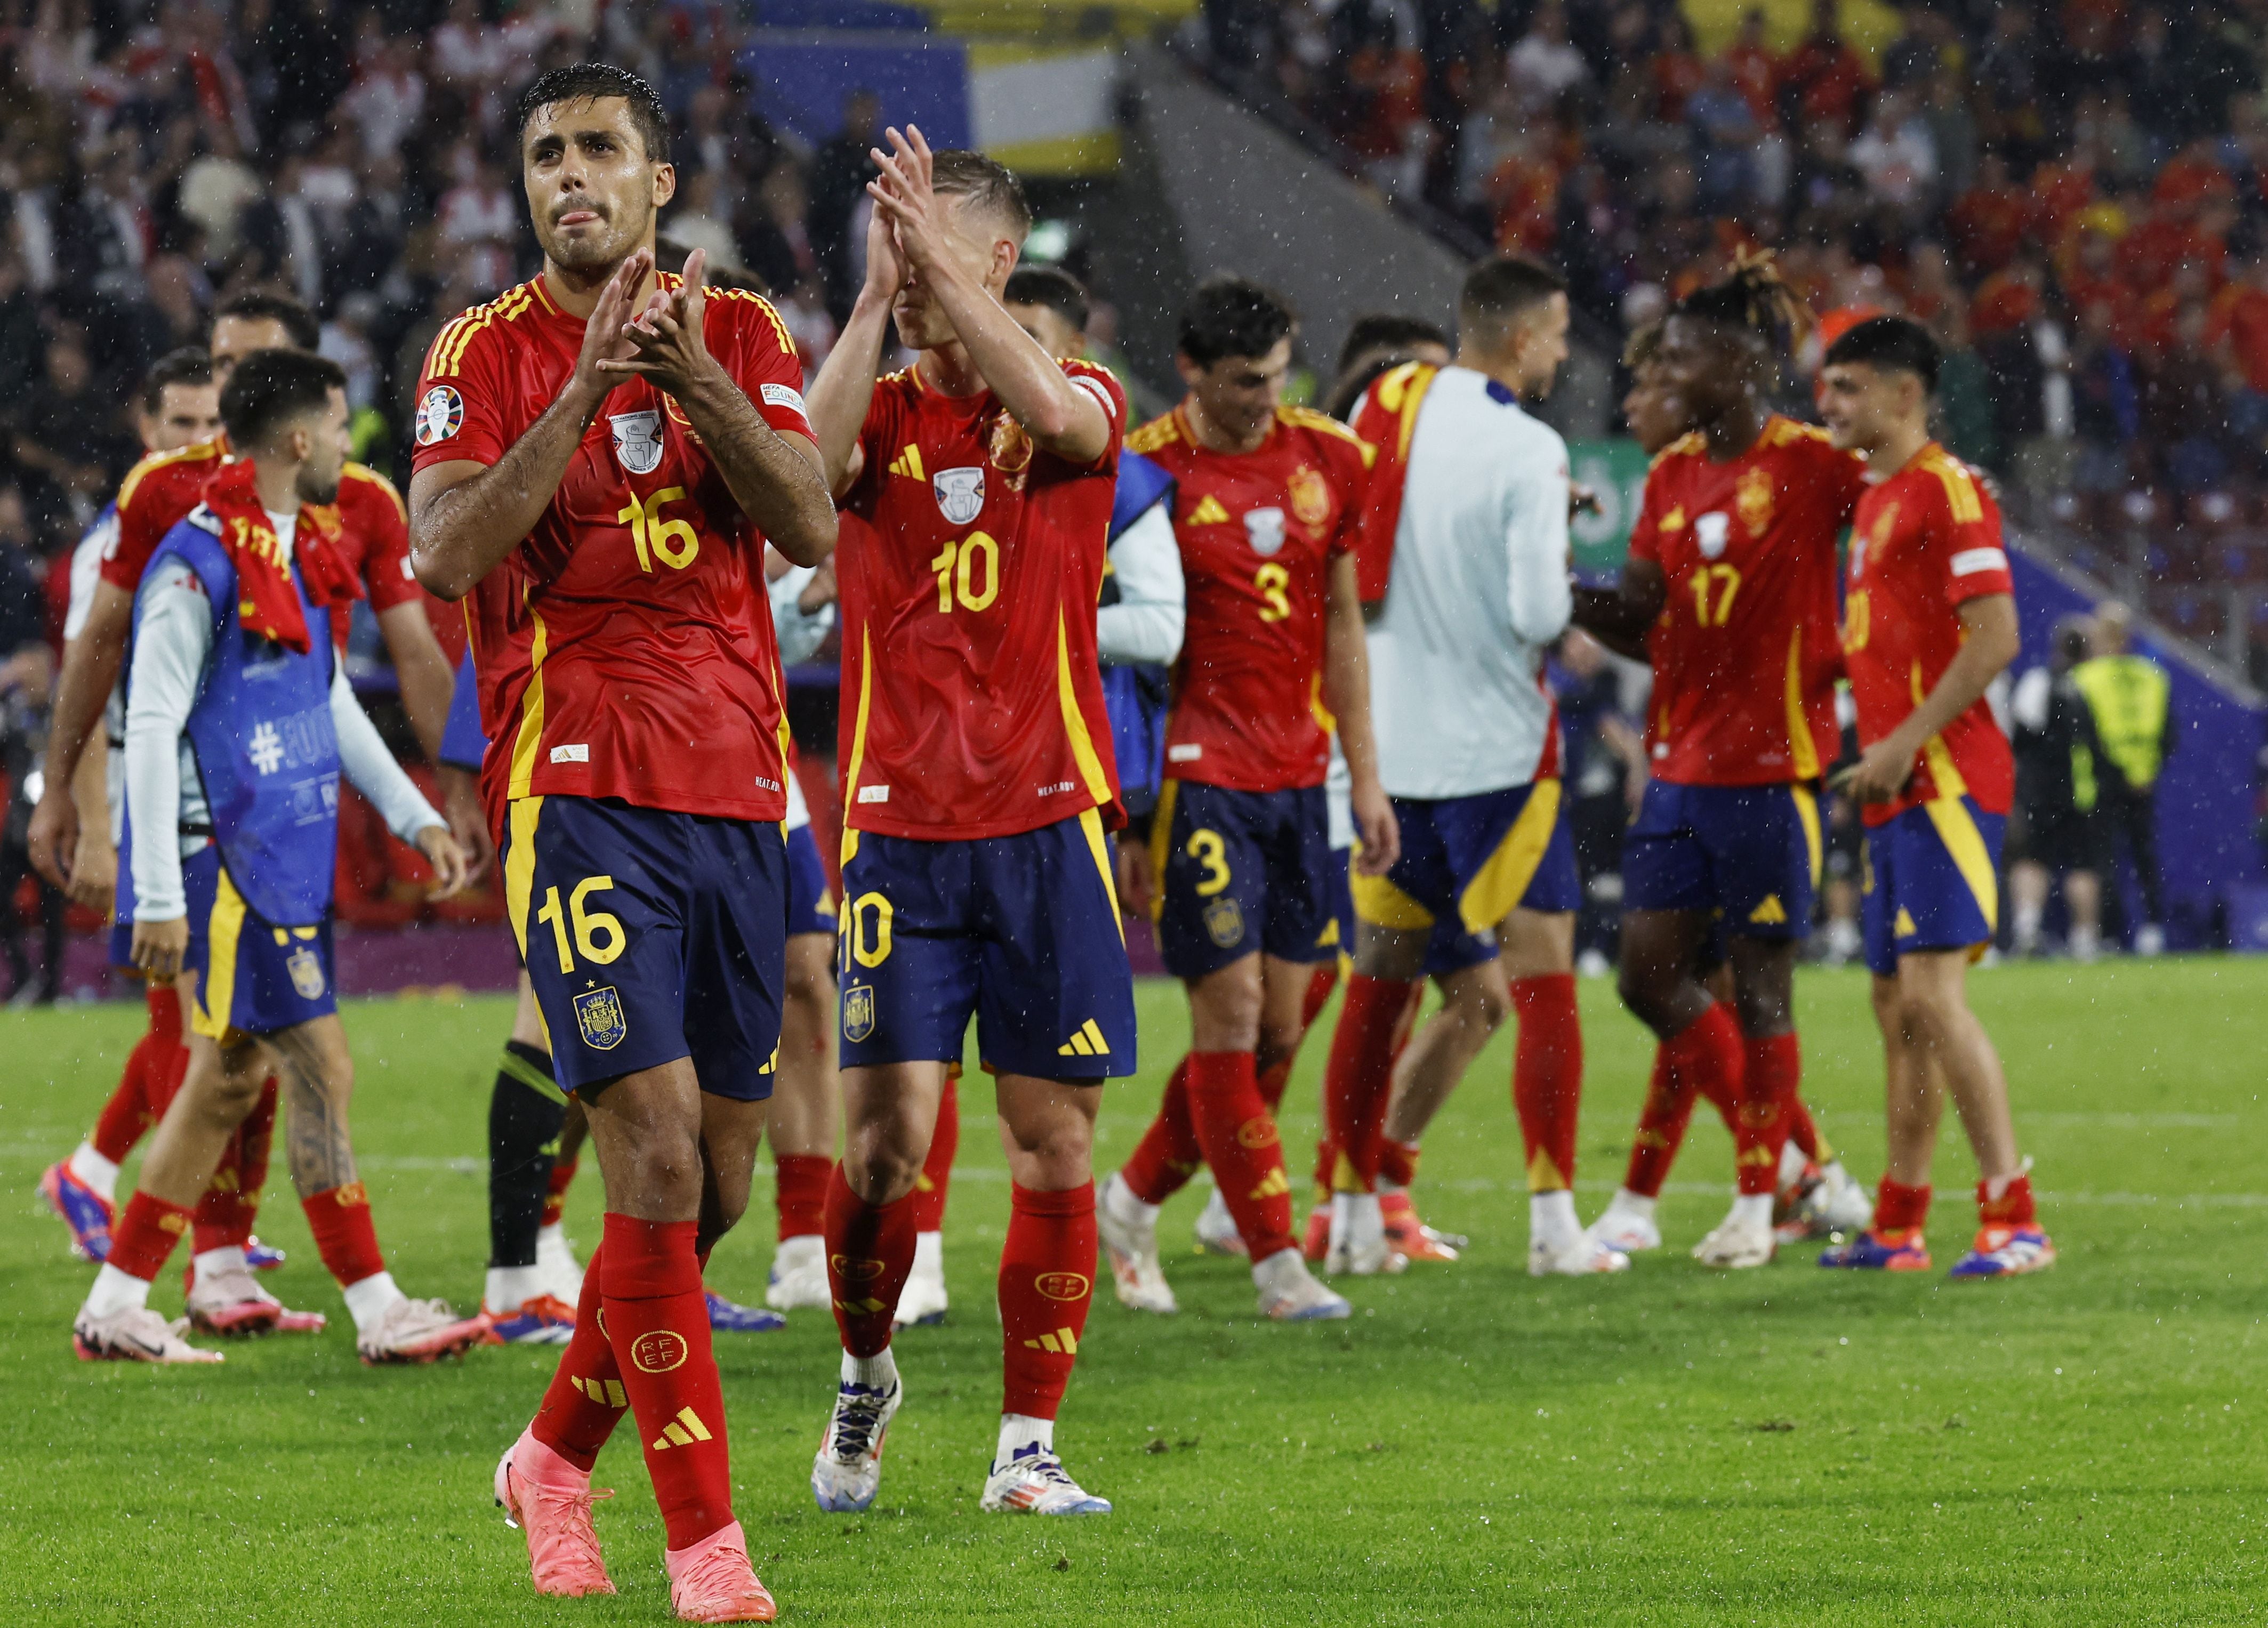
[599,249,834,565]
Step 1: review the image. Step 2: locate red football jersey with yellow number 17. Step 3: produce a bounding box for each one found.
[1631,415,1867,787]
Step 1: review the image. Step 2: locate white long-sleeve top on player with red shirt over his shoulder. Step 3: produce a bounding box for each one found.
[1370,367,1574,800]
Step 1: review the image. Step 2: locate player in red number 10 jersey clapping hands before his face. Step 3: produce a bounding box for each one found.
[812,129,1134,1514]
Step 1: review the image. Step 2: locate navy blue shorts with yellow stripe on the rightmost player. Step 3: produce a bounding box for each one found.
[1860,796,2007,977]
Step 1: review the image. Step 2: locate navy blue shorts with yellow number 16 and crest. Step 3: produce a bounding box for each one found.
[499,796,787,1102]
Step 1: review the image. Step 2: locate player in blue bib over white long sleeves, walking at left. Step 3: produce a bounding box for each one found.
[73,351,483,1363]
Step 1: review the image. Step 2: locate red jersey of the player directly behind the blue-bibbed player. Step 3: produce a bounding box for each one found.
[102,436,424,648]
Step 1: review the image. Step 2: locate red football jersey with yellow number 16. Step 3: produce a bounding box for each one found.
[417,275,812,823]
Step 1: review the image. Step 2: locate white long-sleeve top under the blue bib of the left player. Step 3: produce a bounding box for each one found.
[125,512,447,925]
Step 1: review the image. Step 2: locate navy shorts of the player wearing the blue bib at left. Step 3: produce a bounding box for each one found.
[182,843,338,1041]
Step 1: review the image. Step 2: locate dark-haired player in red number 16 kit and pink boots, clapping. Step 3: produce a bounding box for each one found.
[411,63,834,1621]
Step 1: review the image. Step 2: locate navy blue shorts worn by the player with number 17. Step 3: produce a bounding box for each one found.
[1622,780,1819,939]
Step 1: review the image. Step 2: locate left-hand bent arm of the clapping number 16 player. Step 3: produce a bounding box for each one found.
[411,249,653,601]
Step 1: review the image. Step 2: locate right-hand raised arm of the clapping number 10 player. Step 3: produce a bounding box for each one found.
[866,125,1116,467]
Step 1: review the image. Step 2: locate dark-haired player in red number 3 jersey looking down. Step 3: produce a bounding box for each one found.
[1098,277,1400,1322]
